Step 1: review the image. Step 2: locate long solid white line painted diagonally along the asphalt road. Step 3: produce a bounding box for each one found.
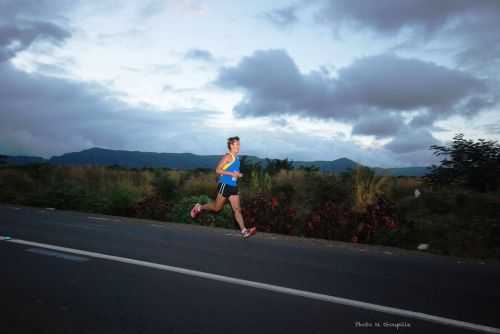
[5,239,500,333]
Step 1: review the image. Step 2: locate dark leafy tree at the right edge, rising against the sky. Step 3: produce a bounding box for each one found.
[426,134,500,192]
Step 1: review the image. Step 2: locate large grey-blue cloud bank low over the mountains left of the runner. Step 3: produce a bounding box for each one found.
[0,63,218,156]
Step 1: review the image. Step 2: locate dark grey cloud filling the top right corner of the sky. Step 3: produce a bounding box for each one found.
[308,0,500,71]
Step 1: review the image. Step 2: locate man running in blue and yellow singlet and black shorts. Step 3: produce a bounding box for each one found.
[191,137,257,239]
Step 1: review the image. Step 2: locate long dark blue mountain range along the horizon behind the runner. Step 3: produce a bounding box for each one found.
[0,148,428,176]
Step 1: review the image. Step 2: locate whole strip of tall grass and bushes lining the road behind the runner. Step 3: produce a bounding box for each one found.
[0,165,500,259]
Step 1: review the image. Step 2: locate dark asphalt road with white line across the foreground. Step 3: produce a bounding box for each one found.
[0,205,500,334]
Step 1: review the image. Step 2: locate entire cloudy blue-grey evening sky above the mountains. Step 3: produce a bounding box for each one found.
[0,0,500,167]
